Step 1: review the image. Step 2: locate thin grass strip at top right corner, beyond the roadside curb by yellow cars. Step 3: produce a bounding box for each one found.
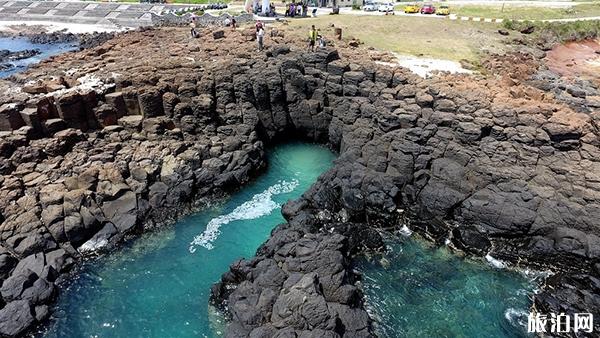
[450,2,600,20]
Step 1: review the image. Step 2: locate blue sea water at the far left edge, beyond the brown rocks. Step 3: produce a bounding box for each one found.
[0,38,77,78]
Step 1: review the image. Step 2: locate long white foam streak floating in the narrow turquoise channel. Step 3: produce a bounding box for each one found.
[189,180,299,253]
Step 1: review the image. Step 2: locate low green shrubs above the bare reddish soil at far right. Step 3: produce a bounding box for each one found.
[502,20,600,44]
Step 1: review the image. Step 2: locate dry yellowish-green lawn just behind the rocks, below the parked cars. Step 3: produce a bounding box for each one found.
[288,15,506,64]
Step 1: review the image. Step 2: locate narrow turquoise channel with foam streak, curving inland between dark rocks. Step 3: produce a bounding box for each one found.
[44,144,335,338]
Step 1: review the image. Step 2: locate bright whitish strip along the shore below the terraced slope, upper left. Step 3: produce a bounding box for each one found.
[0,21,123,34]
